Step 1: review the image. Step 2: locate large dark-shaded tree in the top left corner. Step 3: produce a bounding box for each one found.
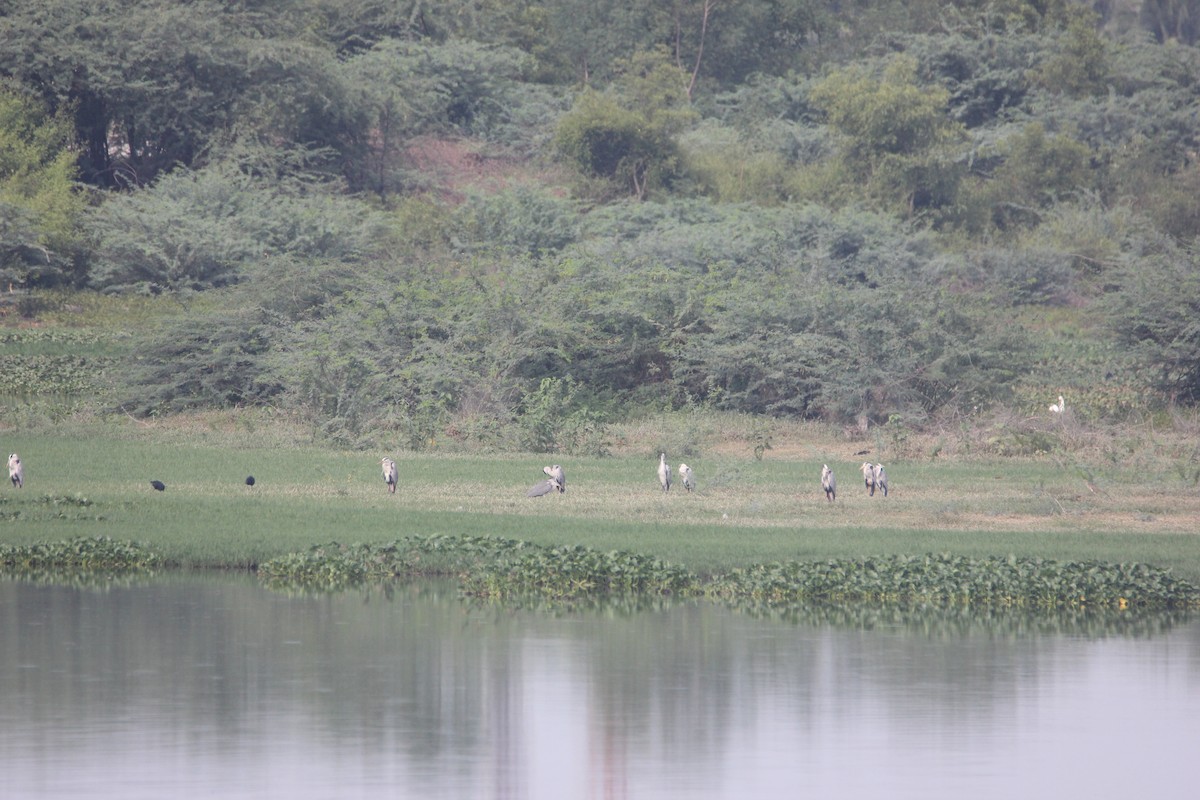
[0,0,361,186]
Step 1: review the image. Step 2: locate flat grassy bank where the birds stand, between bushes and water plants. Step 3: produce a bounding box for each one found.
[0,424,1200,582]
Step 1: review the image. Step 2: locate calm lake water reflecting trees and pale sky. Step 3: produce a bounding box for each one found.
[0,575,1200,800]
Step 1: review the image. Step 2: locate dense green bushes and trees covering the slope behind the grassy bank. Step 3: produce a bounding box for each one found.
[0,0,1200,455]
